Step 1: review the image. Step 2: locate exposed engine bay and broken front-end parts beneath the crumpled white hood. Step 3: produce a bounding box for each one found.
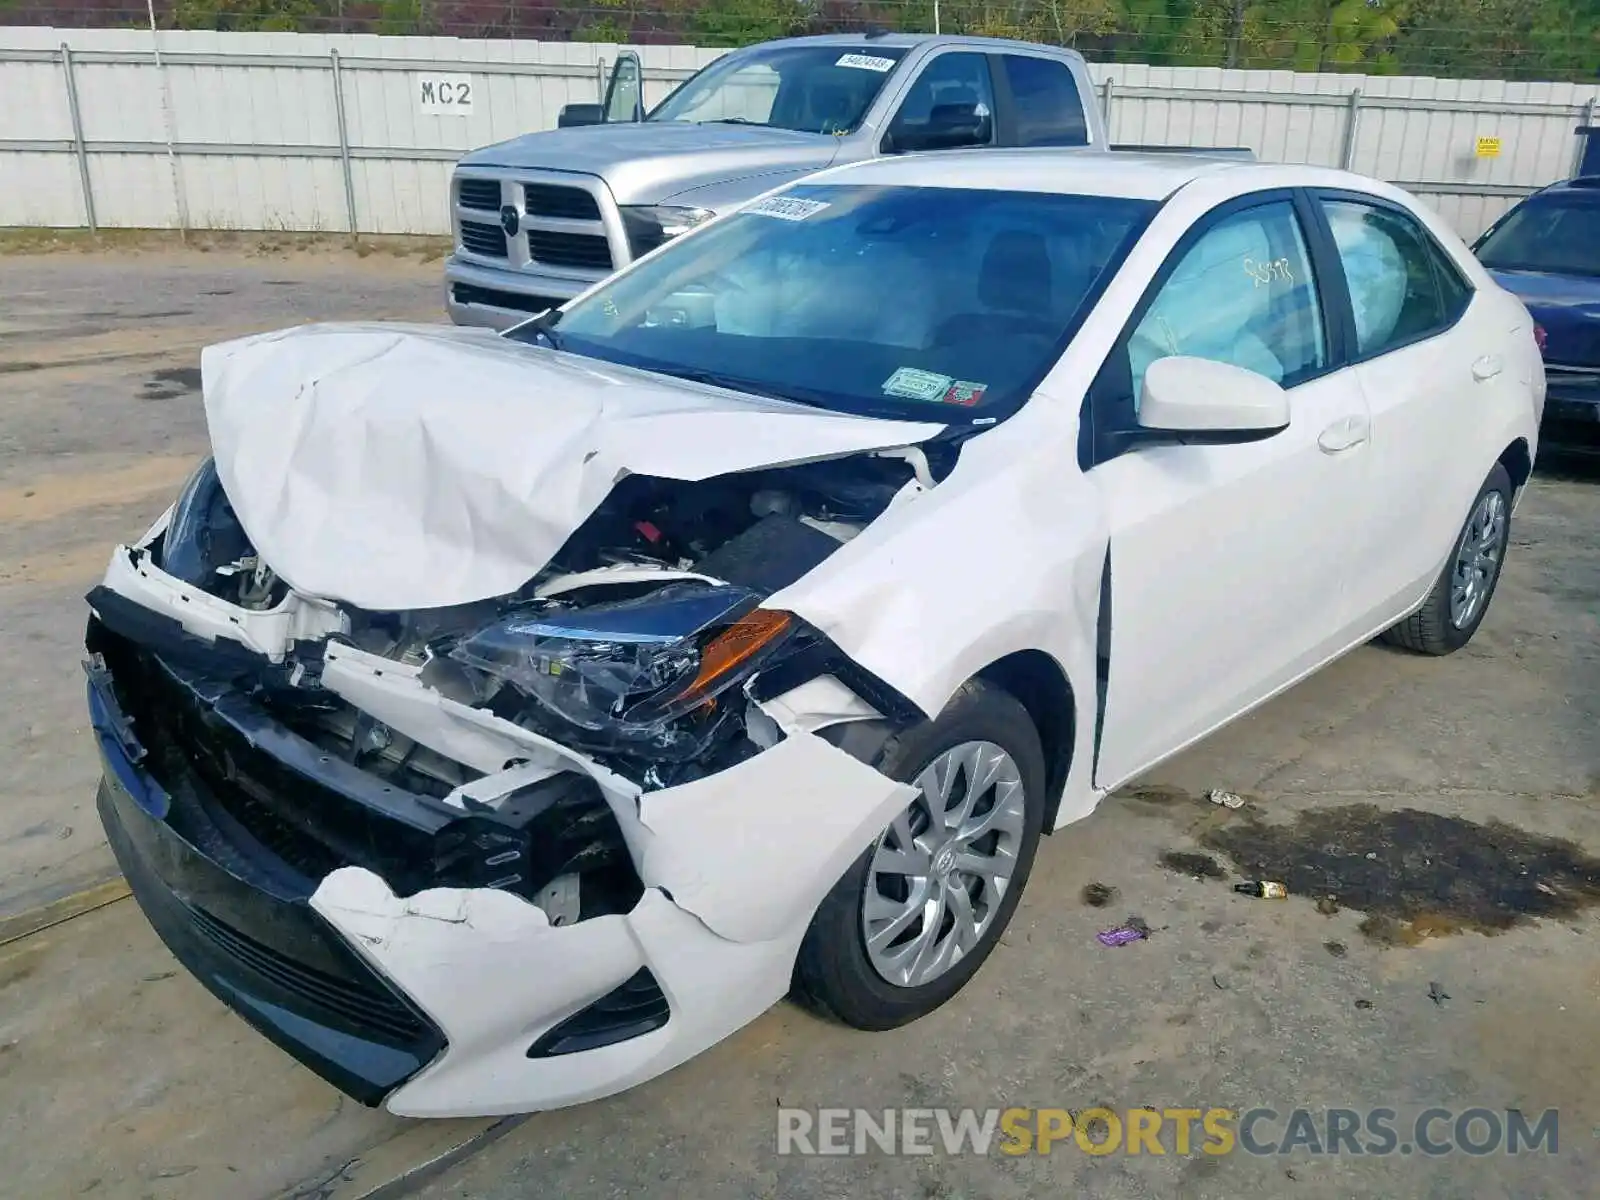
[90,446,934,923]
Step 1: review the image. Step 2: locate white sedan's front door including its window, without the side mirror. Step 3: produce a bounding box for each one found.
[1088,194,1368,787]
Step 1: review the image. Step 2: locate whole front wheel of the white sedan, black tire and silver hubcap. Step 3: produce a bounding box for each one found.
[795,682,1045,1029]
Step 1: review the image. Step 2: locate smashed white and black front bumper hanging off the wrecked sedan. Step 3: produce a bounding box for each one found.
[88,552,912,1117]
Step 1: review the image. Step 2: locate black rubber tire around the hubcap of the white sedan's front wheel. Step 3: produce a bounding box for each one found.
[795,682,1045,1030]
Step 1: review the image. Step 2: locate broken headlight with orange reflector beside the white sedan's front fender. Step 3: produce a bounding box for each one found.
[450,584,795,760]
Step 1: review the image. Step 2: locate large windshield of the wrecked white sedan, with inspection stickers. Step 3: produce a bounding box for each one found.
[510,184,1155,422]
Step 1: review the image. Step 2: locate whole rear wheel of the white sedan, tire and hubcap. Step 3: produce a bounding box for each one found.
[1382,462,1512,654]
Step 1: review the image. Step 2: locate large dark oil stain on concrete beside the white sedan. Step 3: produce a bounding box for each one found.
[1200,805,1600,946]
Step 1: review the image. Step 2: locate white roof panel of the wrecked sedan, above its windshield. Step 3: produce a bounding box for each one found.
[806,147,1292,200]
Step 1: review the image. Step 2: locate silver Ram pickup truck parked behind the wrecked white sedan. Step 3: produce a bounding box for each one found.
[445,34,1250,328]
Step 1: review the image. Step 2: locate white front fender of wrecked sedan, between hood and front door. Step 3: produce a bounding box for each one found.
[766,400,1110,824]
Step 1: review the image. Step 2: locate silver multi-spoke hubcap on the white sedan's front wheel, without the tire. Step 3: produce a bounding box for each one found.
[861,742,1026,987]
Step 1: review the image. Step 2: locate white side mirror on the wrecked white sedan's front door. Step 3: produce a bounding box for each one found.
[1139,355,1290,443]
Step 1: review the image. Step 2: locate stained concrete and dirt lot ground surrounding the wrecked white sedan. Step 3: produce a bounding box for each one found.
[0,251,1600,1200]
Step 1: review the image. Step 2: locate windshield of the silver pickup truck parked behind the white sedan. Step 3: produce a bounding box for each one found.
[646,45,906,133]
